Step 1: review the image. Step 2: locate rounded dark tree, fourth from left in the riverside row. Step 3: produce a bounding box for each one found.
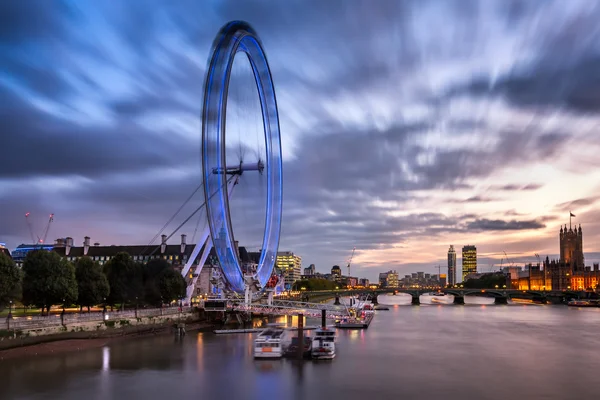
[104,252,143,305]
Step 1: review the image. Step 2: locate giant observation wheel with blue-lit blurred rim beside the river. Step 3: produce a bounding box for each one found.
[202,21,283,293]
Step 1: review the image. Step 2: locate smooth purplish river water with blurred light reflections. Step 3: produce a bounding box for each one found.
[0,296,600,400]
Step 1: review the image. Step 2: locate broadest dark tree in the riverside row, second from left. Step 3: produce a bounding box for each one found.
[23,250,78,314]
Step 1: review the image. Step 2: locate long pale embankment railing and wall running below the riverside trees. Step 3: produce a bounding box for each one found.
[0,307,192,330]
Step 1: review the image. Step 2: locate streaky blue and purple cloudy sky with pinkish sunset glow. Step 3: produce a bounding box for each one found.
[0,0,600,279]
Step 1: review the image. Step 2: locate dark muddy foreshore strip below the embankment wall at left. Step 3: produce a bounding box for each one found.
[0,321,216,362]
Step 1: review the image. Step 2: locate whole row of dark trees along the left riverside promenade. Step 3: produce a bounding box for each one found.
[0,250,187,313]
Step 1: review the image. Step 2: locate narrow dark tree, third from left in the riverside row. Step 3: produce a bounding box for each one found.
[75,257,110,312]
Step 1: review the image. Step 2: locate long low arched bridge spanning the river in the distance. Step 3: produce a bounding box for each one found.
[302,288,600,305]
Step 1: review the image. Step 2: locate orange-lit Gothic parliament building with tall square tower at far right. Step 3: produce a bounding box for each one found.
[518,225,600,290]
